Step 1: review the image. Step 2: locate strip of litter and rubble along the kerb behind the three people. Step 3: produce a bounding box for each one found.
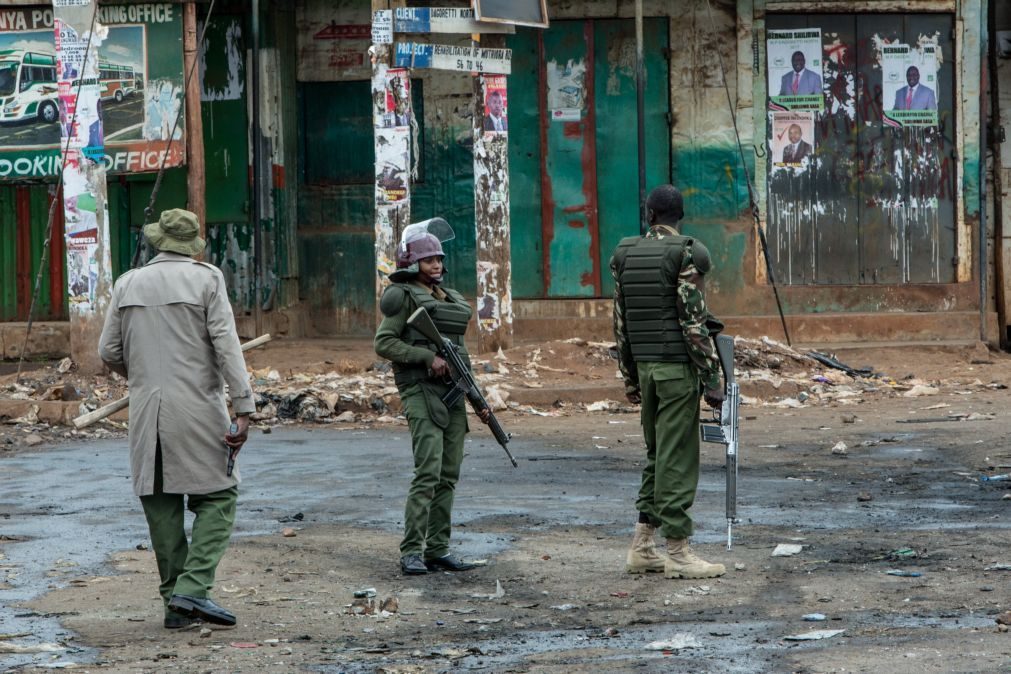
[0,336,1006,442]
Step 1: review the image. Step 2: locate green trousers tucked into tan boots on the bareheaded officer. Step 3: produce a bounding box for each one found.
[636,363,699,539]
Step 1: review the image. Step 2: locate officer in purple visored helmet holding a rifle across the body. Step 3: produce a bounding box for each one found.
[375,217,488,575]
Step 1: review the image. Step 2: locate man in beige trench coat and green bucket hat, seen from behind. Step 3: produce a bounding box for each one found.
[99,209,256,629]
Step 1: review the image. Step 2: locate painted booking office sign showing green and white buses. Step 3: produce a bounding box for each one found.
[0,3,185,179]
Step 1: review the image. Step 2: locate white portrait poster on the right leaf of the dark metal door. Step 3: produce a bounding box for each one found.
[881,44,938,127]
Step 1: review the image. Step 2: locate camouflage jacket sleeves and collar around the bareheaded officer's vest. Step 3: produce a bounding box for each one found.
[611,224,720,393]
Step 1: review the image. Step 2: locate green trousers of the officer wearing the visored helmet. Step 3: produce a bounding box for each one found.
[400,384,468,559]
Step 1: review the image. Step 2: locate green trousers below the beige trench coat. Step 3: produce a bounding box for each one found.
[141,447,239,605]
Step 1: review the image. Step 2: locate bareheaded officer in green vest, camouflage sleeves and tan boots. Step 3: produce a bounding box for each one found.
[611,185,726,578]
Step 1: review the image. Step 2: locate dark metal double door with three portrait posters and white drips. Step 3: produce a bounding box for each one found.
[756,12,954,286]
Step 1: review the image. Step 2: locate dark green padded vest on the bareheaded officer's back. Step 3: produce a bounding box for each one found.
[615,235,692,363]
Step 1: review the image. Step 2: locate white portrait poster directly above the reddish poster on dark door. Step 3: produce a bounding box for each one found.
[765,28,825,112]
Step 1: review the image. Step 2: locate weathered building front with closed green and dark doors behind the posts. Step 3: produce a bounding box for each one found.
[0,0,1011,353]
